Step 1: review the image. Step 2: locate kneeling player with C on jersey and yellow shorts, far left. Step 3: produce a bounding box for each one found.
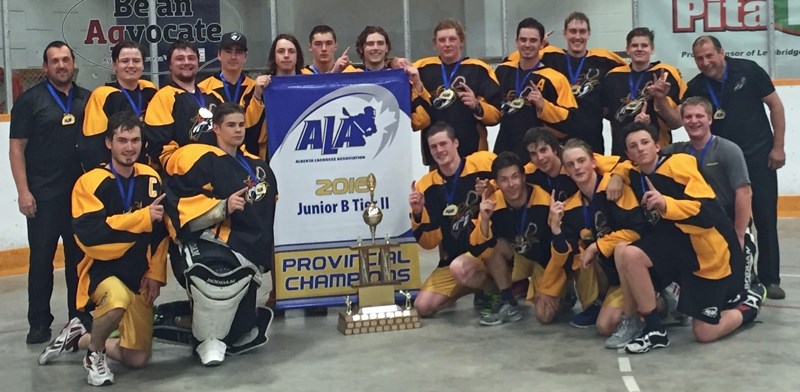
[39,111,167,386]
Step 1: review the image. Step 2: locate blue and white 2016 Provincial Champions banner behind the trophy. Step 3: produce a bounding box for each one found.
[264,70,420,308]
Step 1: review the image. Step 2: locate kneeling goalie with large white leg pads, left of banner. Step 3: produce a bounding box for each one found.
[165,103,277,366]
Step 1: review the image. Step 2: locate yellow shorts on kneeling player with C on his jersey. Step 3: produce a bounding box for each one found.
[92,276,153,351]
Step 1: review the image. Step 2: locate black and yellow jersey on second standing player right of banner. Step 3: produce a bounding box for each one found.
[494,61,581,162]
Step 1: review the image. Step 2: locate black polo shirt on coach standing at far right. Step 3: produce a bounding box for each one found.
[683,56,775,161]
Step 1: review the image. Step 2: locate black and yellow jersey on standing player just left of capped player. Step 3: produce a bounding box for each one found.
[144,82,223,167]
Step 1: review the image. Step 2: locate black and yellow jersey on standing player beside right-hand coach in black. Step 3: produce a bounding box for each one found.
[603,62,686,156]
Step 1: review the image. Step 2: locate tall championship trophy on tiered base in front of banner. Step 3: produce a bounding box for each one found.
[337,173,421,335]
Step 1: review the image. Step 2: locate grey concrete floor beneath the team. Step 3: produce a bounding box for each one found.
[0,219,800,392]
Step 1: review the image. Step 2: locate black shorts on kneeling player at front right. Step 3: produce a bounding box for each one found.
[631,222,744,324]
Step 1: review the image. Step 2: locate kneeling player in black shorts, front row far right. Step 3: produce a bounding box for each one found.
[616,123,766,353]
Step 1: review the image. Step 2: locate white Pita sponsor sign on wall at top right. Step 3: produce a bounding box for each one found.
[638,0,800,81]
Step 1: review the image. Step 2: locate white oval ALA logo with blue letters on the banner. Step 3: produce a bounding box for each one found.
[276,84,402,162]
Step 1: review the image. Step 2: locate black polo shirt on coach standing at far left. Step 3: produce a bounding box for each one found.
[10,80,91,201]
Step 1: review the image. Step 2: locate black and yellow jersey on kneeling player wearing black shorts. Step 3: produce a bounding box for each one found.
[621,154,738,280]
